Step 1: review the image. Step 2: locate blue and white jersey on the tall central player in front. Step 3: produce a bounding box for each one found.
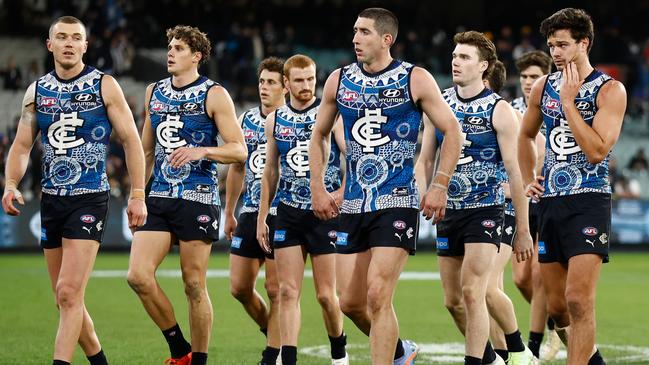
[336,60,421,214]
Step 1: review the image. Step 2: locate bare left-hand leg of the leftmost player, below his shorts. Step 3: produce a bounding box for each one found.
[54,238,99,362]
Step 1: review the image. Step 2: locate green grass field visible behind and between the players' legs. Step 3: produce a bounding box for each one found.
[0,253,649,365]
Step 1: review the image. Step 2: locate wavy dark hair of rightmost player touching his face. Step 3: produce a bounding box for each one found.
[539,8,595,52]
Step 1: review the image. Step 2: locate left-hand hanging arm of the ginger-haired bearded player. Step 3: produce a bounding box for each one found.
[257,112,279,252]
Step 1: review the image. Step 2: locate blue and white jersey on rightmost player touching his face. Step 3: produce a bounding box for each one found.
[541,70,612,197]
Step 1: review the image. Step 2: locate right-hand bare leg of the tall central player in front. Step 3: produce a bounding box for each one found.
[367,247,408,364]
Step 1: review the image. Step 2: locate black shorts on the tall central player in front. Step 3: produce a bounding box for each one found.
[336,208,419,255]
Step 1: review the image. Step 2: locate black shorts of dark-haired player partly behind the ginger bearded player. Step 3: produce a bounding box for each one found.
[230,212,275,260]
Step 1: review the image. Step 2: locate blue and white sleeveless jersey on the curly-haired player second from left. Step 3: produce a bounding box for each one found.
[148,76,220,205]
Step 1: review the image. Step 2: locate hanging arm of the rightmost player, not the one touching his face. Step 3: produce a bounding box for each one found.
[518,76,547,200]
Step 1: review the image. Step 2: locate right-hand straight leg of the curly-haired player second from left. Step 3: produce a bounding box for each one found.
[180,240,213,365]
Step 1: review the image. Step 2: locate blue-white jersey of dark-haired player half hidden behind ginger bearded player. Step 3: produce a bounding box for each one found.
[241,107,279,215]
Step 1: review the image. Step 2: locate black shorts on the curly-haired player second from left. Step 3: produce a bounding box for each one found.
[137,197,221,243]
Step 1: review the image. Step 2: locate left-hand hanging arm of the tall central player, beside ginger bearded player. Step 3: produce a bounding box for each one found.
[309,69,344,220]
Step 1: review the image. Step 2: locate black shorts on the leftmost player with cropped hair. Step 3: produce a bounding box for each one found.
[41,191,110,248]
